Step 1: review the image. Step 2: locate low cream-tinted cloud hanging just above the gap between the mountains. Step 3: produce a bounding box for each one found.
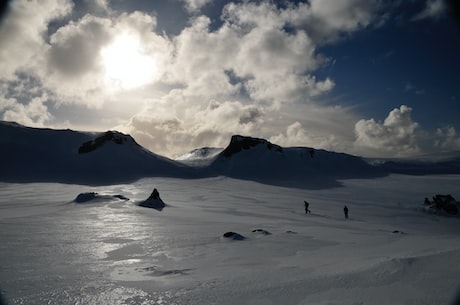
[117,96,264,157]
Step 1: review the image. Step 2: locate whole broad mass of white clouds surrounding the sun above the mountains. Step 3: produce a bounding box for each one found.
[6,0,434,156]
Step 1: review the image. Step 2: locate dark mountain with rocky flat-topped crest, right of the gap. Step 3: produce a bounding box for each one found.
[202,135,386,188]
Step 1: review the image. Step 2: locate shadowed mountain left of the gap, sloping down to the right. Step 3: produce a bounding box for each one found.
[0,122,192,184]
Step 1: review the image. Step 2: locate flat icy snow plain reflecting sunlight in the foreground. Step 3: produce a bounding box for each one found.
[0,175,460,305]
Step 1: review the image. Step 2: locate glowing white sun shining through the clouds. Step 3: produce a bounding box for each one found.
[100,34,158,89]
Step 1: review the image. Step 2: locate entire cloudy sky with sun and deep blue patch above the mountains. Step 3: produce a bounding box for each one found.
[0,0,460,158]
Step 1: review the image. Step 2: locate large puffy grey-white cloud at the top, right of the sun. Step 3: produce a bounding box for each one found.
[168,2,334,102]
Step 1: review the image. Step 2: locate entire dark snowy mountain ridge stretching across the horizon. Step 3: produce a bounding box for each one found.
[0,122,460,188]
